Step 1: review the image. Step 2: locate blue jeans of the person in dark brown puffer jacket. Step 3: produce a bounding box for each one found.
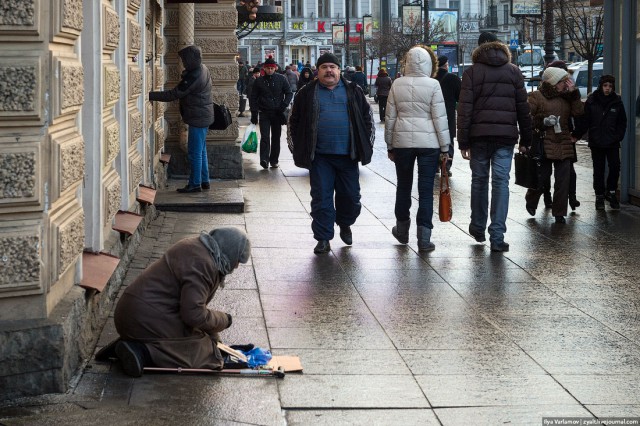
[469,142,513,245]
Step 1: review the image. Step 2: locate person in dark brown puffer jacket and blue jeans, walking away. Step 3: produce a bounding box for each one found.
[457,32,531,252]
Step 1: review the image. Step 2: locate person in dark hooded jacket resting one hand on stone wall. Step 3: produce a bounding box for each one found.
[149,46,214,192]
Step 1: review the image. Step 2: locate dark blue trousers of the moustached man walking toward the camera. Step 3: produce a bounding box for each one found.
[309,154,362,241]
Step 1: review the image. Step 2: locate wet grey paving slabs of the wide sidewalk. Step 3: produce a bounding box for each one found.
[0,104,640,425]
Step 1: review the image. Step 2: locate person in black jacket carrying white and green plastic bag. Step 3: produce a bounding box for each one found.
[249,58,293,169]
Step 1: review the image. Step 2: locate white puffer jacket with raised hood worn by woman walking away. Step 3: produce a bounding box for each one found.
[384,47,450,152]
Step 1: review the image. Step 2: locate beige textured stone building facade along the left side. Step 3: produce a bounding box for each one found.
[0,0,243,399]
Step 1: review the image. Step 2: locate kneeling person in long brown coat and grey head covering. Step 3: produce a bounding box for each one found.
[114,227,251,377]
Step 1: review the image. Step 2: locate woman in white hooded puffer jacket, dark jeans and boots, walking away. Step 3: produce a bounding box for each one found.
[384,46,449,251]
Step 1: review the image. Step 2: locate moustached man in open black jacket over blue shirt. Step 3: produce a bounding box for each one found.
[288,53,375,254]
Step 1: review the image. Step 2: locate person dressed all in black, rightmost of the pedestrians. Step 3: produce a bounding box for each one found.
[575,74,627,210]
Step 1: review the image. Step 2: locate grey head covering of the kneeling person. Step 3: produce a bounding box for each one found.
[200,226,251,275]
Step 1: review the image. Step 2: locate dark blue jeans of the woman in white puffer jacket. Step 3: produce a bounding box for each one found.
[393,148,440,229]
